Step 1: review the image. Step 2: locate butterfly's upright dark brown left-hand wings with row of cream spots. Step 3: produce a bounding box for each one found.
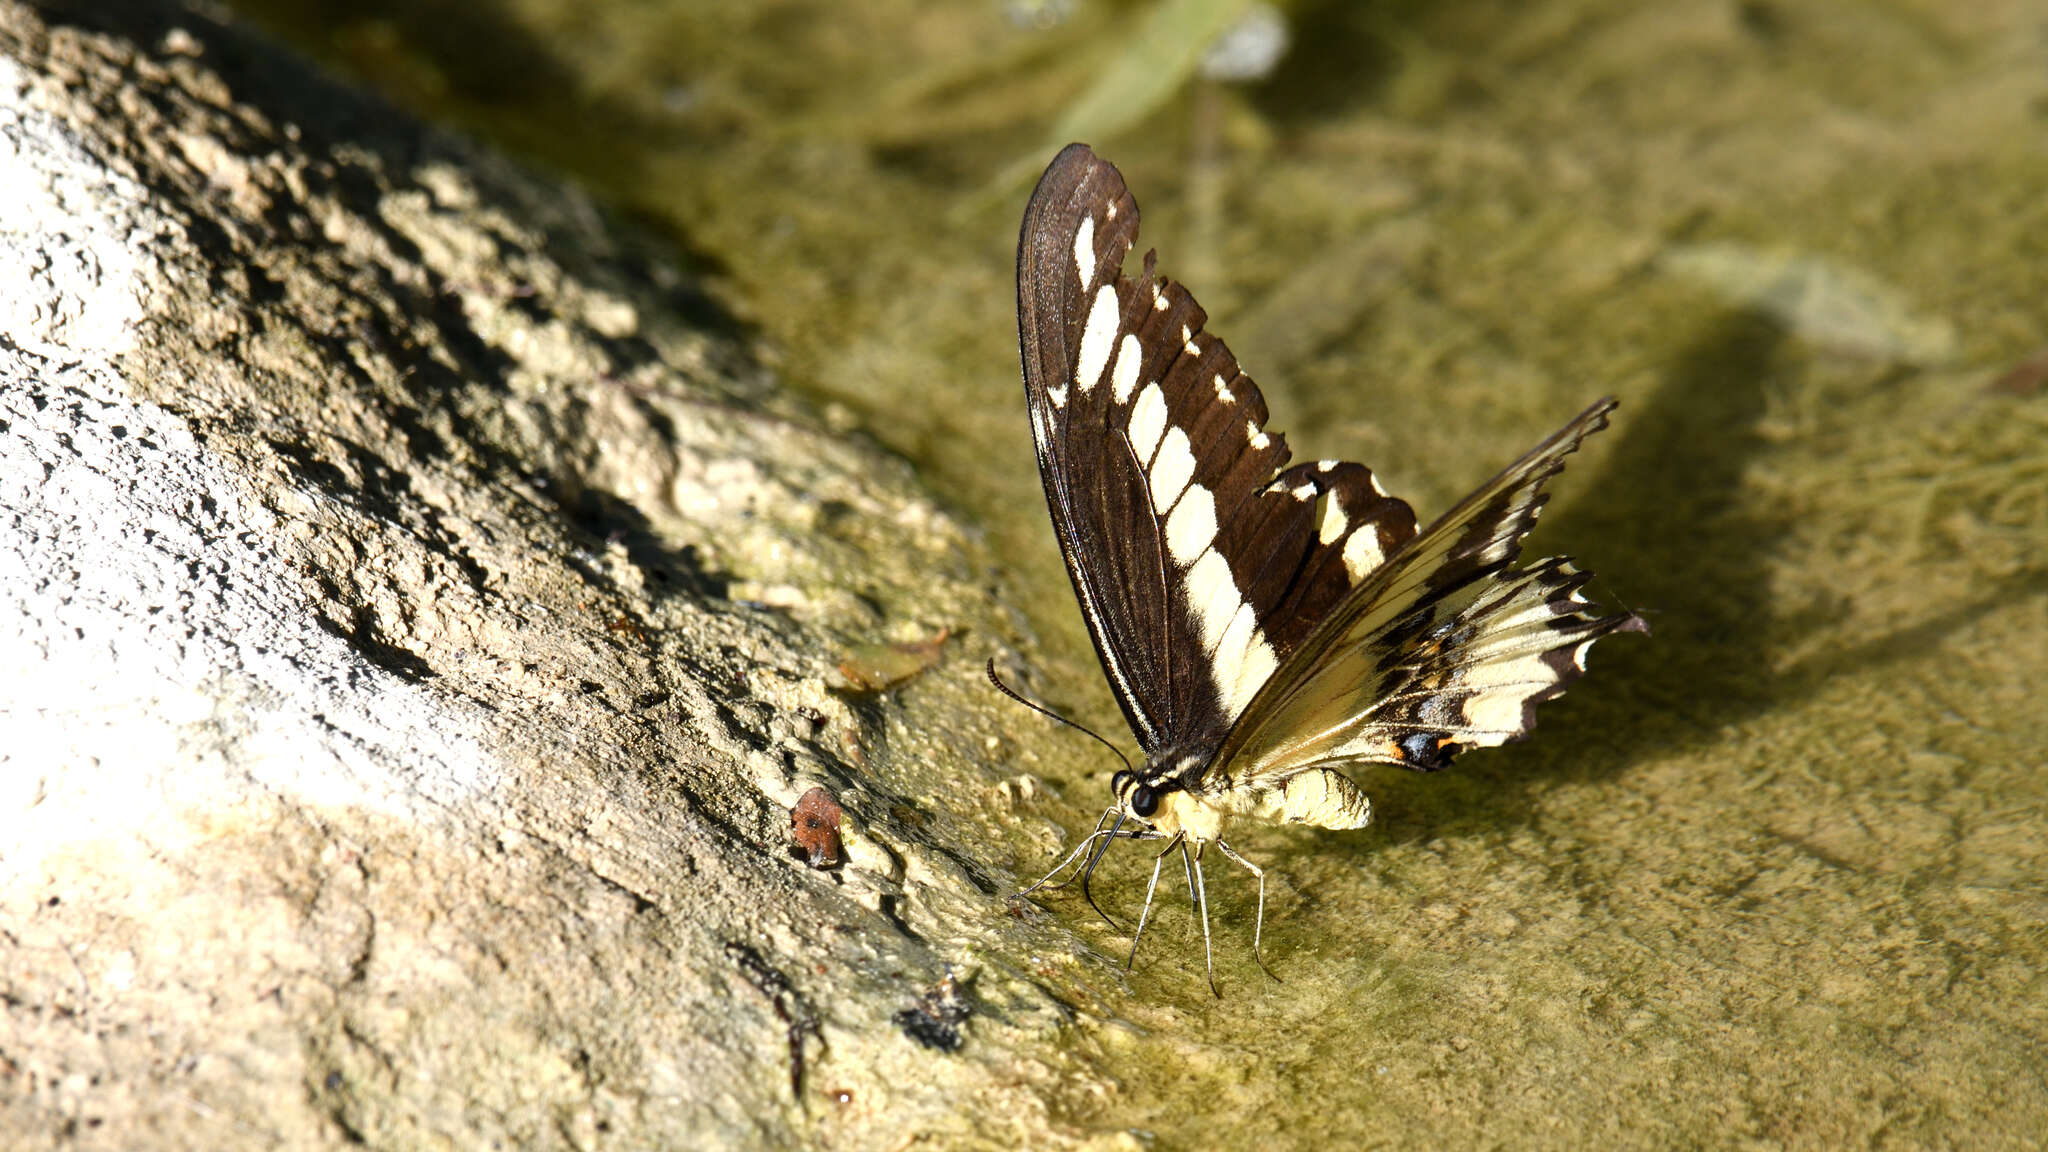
[1018,146,1415,760]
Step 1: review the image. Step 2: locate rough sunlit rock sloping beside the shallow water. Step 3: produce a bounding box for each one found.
[0,2,1122,1150]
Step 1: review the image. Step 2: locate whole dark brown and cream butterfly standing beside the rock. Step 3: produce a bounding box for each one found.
[1007,143,1649,990]
